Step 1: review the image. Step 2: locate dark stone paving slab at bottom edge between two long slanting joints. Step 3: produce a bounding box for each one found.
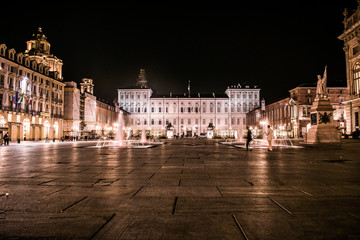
[95,214,243,240]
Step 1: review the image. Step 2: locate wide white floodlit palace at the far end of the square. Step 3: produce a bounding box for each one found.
[118,69,260,137]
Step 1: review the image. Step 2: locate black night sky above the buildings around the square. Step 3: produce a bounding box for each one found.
[0,0,357,103]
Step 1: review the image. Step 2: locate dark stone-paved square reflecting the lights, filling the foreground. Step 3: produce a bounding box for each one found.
[0,139,360,240]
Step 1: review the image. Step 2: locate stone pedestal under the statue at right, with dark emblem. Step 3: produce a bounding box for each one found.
[306,98,340,144]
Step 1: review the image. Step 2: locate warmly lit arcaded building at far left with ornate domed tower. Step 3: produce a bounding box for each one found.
[0,28,65,141]
